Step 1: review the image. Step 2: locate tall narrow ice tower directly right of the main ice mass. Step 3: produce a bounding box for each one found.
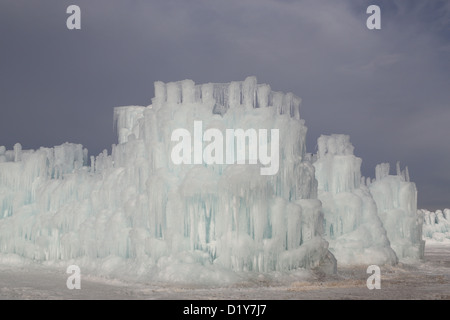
[314,134,397,265]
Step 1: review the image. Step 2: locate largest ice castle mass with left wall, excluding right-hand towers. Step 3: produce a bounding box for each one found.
[0,77,332,281]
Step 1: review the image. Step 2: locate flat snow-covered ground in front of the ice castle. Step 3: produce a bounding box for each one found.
[0,242,450,300]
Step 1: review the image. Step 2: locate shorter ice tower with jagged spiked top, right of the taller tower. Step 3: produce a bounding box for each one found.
[369,163,425,260]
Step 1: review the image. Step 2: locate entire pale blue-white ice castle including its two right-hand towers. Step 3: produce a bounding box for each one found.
[0,77,426,283]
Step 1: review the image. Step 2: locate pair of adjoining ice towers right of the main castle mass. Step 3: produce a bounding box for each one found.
[314,134,425,264]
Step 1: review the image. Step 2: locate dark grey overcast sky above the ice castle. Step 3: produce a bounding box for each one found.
[0,0,450,210]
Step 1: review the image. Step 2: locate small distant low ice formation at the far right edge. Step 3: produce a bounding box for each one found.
[418,209,450,242]
